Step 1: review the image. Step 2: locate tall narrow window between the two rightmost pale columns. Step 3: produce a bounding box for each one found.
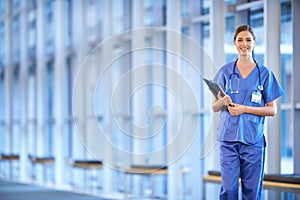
[280,2,294,173]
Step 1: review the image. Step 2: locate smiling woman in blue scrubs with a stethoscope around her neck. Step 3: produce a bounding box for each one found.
[212,25,283,200]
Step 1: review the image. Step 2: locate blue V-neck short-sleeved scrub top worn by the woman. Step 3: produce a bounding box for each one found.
[214,61,283,147]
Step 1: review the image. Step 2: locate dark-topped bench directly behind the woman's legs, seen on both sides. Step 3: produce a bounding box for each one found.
[203,171,300,197]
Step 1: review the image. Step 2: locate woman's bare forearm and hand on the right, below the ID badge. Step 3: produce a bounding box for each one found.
[228,100,277,116]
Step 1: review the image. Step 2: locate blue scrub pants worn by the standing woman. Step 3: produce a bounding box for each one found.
[220,142,265,200]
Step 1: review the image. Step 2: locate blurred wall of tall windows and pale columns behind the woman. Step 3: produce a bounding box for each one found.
[0,0,300,199]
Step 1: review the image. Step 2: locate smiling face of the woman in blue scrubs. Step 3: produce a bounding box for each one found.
[234,31,256,56]
